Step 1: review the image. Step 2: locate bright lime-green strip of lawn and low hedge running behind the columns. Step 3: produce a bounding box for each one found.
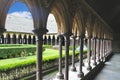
[0,49,87,72]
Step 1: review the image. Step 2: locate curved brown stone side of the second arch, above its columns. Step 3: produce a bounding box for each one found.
[50,1,69,34]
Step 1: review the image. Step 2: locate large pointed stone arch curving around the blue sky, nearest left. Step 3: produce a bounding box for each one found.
[0,0,35,29]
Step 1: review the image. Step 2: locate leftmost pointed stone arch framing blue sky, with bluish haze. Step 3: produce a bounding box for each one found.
[0,0,38,29]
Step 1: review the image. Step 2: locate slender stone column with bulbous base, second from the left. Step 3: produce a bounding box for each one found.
[57,35,64,79]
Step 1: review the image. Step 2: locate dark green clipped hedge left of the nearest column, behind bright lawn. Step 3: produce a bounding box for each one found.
[0,47,36,59]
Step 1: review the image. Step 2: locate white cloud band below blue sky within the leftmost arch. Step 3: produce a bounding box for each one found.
[9,11,32,18]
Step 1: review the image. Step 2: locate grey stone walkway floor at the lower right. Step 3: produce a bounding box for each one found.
[94,54,120,80]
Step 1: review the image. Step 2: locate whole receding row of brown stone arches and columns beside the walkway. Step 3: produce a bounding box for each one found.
[0,0,112,80]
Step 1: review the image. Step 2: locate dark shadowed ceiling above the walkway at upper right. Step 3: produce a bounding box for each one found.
[86,0,120,33]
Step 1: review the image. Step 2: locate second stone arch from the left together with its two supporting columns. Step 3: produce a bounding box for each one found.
[49,1,71,80]
